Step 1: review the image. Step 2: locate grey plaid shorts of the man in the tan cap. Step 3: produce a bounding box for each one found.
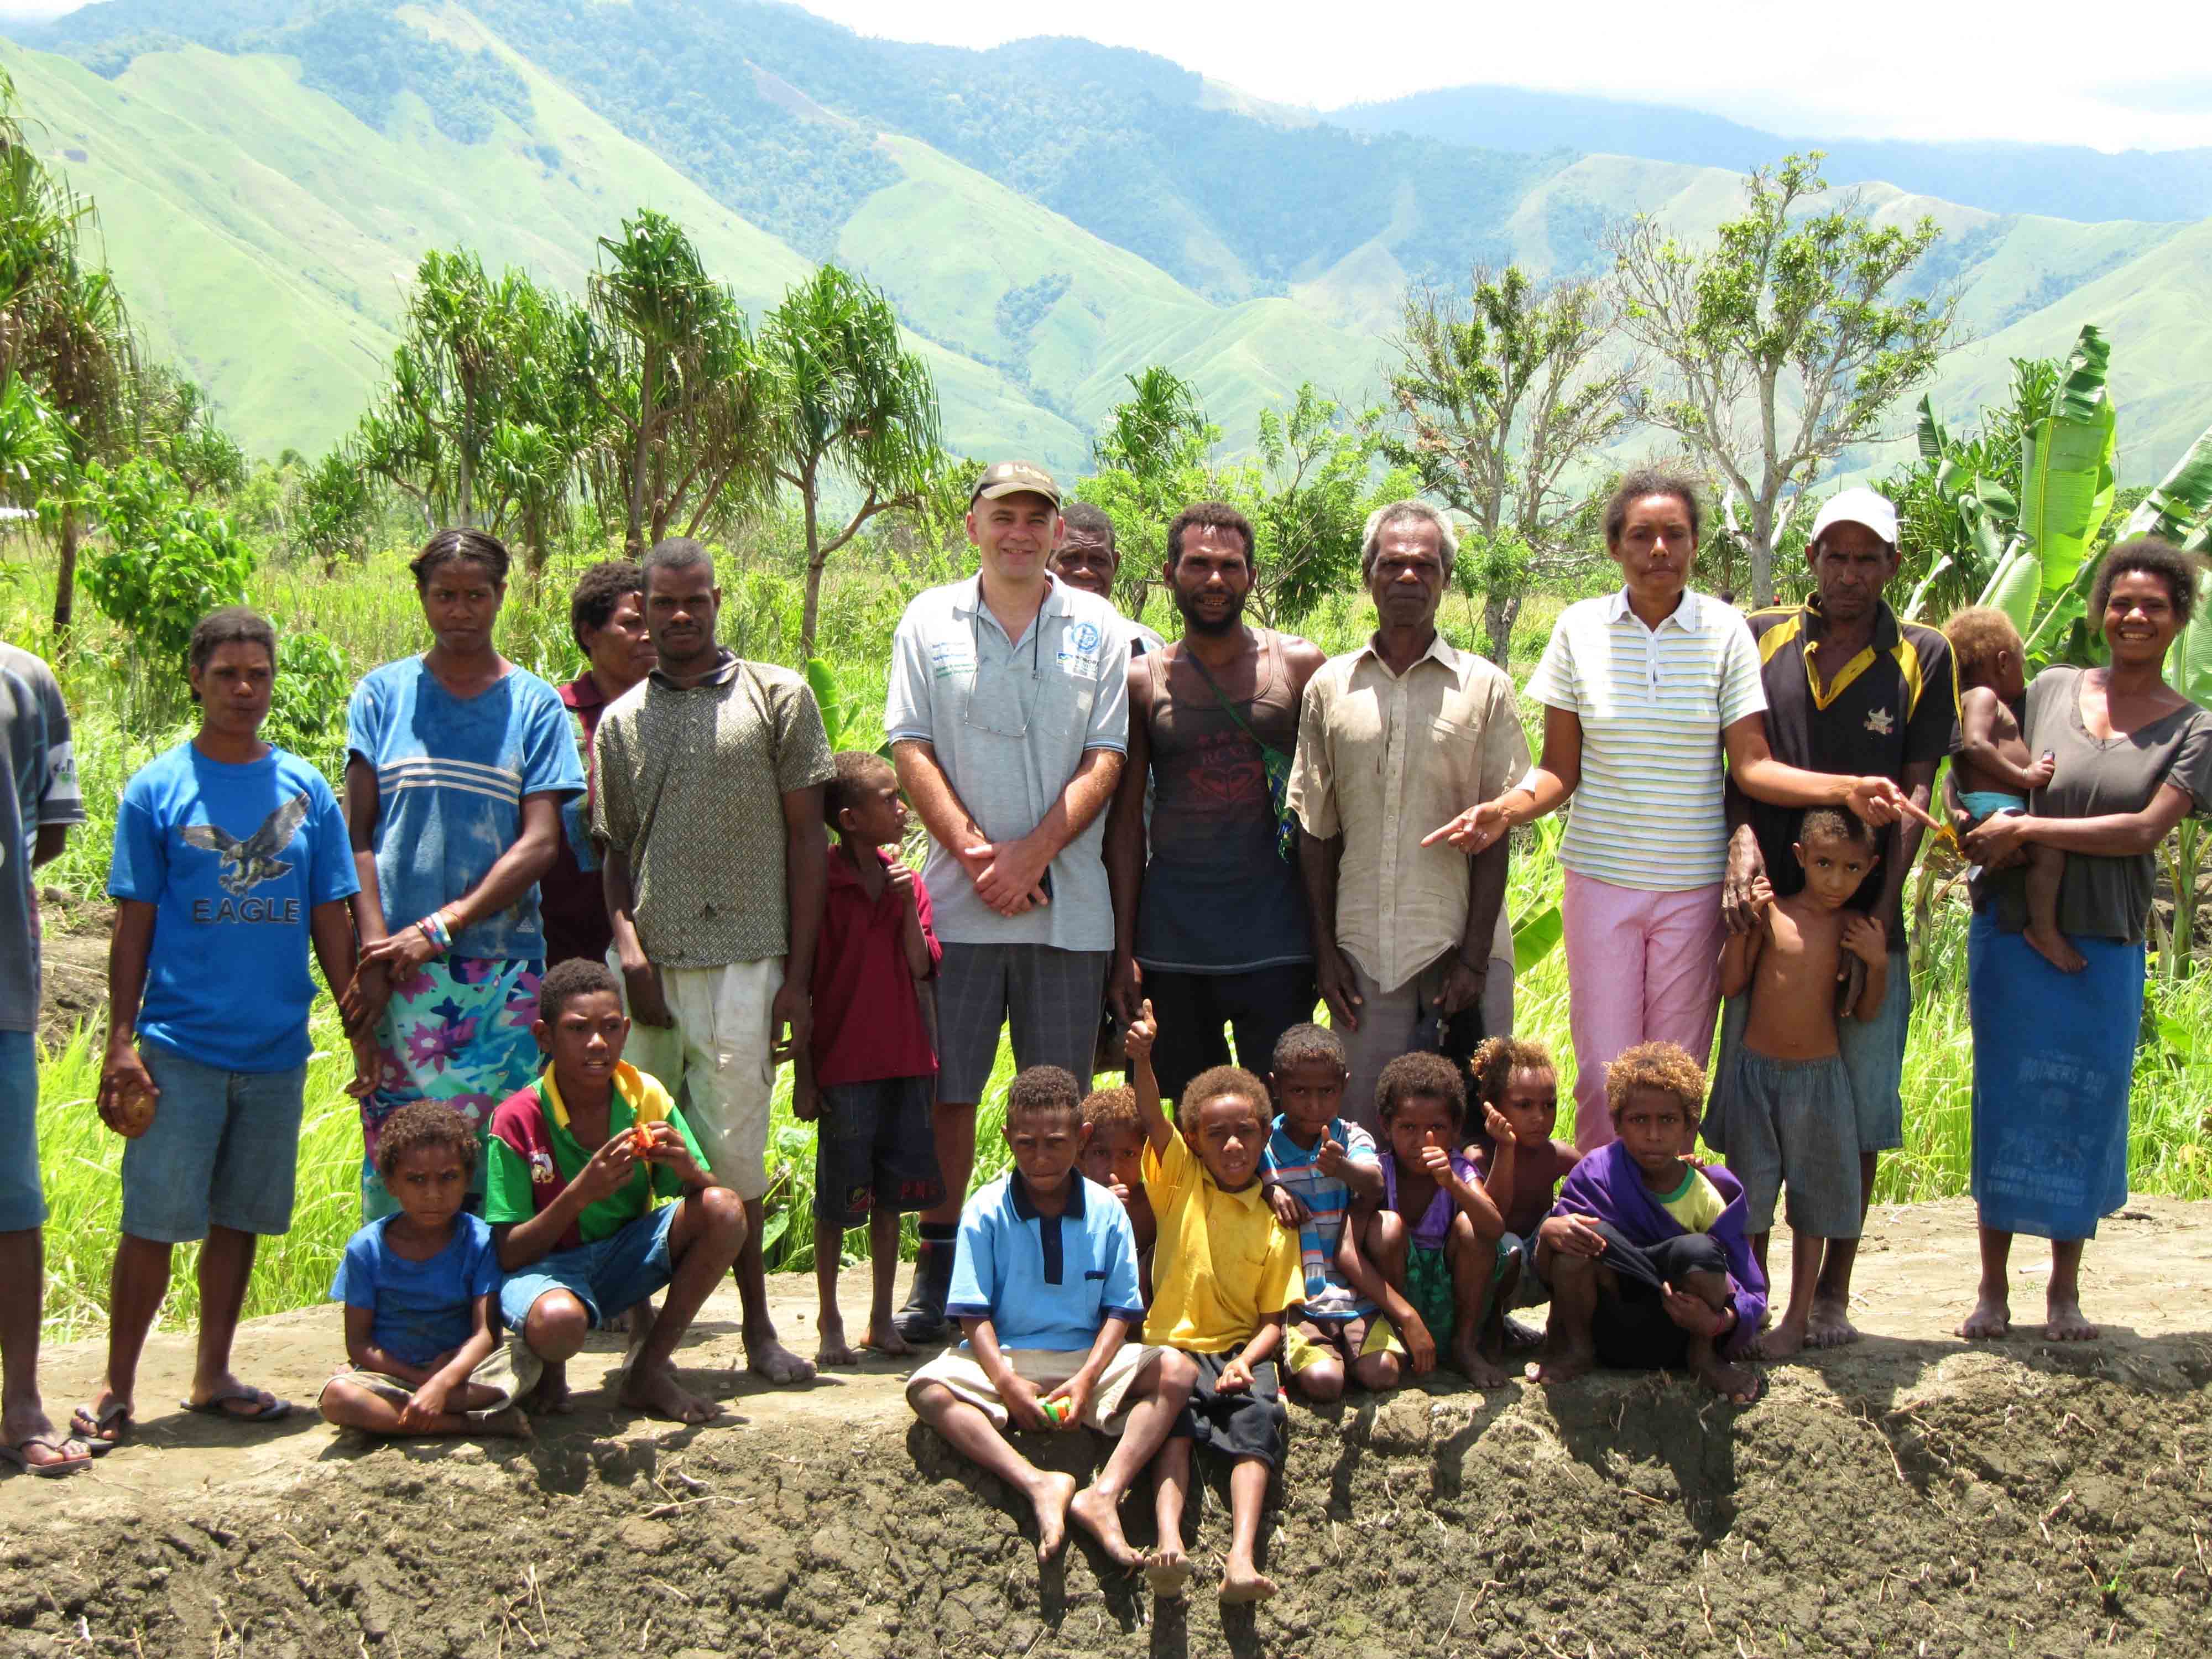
[938,942,1113,1106]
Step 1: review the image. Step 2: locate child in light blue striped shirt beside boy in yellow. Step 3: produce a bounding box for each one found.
[1259,1024,1405,1400]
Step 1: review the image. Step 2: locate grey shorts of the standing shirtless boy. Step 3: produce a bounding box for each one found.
[1728,1046,1863,1239]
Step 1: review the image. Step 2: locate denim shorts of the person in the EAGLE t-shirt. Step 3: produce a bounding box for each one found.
[124,1042,307,1243]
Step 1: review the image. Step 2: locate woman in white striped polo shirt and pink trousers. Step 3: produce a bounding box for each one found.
[1431,469,1905,1152]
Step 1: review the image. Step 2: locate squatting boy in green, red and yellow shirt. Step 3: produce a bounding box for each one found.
[484,958,745,1422]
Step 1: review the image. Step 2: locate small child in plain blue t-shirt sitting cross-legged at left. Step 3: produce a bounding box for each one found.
[319,1099,538,1438]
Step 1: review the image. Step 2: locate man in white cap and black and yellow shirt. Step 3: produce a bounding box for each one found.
[1708,489,1958,1347]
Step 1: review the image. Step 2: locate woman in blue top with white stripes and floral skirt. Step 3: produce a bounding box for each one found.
[345,531,584,1221]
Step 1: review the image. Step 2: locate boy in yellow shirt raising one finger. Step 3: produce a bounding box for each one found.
[1124,1002,1305,1604]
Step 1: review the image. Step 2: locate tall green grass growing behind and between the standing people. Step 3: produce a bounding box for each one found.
[17,546,2212,1338]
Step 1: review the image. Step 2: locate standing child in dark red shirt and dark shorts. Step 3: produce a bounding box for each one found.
[792,750,945,1365]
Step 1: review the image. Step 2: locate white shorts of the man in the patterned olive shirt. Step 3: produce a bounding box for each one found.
[606,951,783,1199]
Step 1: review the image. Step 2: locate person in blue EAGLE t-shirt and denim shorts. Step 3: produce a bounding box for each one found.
[73,606,358,1453]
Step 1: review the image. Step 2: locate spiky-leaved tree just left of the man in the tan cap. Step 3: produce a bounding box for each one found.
[761,265,938,657]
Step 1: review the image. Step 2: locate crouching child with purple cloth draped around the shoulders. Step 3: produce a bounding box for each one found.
[1528,1042,1767,1405]
